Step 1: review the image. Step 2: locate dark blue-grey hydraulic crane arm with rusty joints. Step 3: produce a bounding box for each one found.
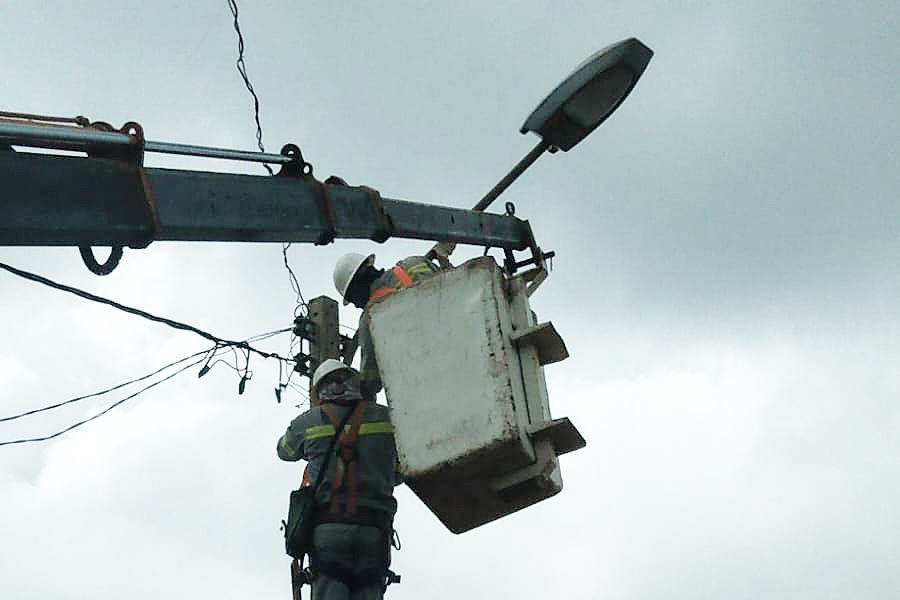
[0,113,547,274]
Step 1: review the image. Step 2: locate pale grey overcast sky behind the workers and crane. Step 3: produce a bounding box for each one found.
[0,0,900,600]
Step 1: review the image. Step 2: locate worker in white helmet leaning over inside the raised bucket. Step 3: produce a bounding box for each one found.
[334,242,455,399]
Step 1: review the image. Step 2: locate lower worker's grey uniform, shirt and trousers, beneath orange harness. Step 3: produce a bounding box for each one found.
[277,402,399,600]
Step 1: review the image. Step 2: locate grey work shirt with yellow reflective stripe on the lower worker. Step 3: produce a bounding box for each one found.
[277,402,400,517]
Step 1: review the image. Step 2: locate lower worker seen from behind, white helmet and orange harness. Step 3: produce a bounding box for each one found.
[278,359,399,600]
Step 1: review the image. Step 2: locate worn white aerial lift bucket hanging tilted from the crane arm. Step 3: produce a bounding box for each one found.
[368,257,585,533]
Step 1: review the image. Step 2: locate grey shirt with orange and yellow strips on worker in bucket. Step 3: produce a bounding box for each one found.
[359,256,440,396]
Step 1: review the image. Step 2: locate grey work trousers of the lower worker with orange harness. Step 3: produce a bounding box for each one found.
[312,523,390,600]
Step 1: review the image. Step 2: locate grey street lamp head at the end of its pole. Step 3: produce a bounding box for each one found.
[521,38,653,151]
